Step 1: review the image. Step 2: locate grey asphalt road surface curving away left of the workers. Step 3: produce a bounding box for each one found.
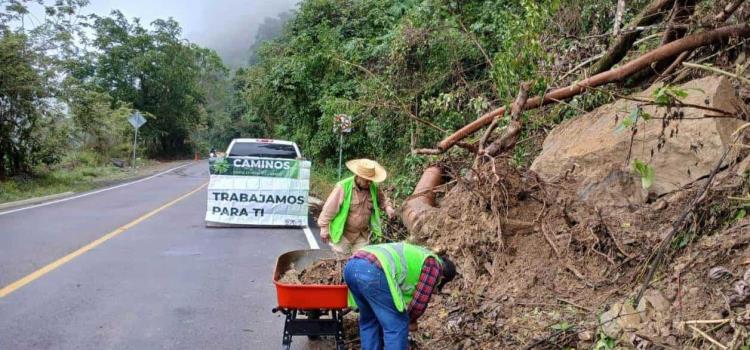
[0,162,328,350]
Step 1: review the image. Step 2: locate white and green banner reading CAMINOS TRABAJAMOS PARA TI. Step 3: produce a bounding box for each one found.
[206,157,311,226]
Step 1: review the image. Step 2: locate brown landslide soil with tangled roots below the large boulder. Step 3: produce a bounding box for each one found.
[411,154,750,349]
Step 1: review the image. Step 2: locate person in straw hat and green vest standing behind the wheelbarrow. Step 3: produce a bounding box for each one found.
[318,159,395,254]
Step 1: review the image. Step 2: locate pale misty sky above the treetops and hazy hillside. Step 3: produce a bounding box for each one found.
[82,0,298,68]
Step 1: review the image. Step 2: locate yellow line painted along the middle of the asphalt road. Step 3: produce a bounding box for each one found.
[0,182,208,298]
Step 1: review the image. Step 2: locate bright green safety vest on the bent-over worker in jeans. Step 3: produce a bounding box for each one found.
[360,242,443,312]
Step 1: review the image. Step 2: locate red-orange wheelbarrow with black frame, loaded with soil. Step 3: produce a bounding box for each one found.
[272,249,348,350]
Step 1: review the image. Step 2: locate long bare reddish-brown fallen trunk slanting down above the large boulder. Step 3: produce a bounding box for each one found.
[424,23,750,154]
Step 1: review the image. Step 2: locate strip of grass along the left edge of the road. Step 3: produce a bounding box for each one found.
[0,152,159,203]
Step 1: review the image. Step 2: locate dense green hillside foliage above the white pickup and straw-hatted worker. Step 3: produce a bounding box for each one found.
[236,0,558,187]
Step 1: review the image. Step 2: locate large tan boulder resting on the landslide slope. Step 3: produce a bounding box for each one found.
[531,76,742,198]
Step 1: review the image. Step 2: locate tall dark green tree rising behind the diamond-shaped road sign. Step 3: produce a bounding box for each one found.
[83,11,213,155]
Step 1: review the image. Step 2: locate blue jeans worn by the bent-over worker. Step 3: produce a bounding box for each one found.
[344,259,409,350]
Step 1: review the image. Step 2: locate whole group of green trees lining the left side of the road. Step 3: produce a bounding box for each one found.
[0,0,232,179]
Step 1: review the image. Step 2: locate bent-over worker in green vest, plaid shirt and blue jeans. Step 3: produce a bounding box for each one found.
[344,242,456,350]
